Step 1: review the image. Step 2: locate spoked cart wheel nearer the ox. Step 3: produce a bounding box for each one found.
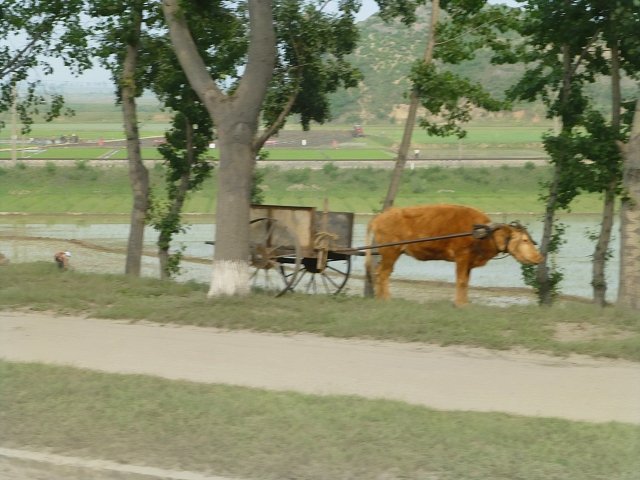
[291,252,351,295]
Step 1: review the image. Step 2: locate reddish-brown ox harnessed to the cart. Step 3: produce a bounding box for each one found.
[367,205,542,306]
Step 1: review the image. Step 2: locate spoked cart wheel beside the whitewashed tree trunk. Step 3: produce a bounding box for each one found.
[249,218,302,297]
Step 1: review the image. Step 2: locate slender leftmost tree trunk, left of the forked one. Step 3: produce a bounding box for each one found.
[120,15,149,276]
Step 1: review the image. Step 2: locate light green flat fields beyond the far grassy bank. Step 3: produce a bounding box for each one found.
[0,117,552,160]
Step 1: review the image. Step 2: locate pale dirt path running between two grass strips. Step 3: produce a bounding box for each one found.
[0,312,640,424]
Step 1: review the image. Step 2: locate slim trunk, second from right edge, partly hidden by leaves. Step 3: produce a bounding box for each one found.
[591,44,622,307]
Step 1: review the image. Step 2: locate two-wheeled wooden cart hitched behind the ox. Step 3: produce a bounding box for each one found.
[250,205,359,296]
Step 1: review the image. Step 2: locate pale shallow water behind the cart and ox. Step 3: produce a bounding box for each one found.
[0,215,619,301]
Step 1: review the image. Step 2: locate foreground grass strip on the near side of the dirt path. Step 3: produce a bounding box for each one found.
[0,362,640,480]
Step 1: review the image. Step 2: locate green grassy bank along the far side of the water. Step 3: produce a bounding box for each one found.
[0,162,601,214]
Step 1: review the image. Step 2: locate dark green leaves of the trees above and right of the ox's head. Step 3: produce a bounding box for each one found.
[496,0,640,303]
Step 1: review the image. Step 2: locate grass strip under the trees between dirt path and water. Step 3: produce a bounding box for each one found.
[0,262,640,361]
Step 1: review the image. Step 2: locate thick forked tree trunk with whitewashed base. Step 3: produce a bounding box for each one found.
[163,0,276,297]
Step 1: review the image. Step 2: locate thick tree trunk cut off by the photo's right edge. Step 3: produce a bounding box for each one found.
[617,99,640,310]
